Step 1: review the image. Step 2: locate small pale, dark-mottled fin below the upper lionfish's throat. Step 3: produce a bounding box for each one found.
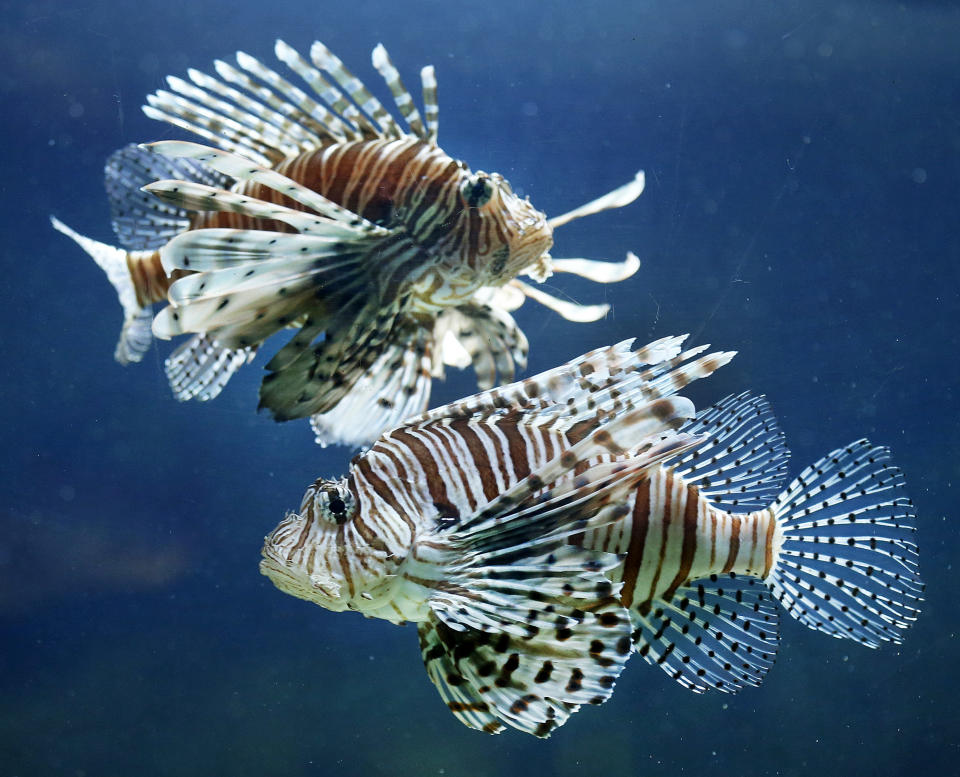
[434,302,529,390]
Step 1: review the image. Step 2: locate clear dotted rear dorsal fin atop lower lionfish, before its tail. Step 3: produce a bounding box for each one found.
[668,391,790,512]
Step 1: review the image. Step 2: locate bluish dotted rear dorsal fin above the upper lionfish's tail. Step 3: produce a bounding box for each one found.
[104,143,233,250]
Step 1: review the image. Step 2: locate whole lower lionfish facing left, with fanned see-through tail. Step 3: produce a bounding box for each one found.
[261,337,923,737]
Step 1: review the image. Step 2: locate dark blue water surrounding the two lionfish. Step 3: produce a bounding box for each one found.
[0,0,960,777]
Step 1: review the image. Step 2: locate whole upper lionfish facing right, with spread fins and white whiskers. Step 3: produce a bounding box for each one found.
[52,41,644,445]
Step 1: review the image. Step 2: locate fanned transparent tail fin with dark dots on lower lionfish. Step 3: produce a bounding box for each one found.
[765,440,923,647]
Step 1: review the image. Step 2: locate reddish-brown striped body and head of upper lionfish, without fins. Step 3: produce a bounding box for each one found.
[181,137,553,314]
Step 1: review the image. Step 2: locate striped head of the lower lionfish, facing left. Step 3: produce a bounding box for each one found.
[260,478,402,612]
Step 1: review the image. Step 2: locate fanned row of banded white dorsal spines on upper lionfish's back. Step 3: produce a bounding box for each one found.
[143,41,437,165]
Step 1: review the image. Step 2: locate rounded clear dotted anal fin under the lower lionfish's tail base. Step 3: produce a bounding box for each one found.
[630,575,779,693]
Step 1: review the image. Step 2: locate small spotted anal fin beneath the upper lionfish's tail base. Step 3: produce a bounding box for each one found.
[163,334,256,402]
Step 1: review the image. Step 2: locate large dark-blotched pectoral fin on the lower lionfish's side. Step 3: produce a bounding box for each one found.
[416,399,691,737]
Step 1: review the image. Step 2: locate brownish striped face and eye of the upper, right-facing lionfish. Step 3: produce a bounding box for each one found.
[460,170,553,286]
